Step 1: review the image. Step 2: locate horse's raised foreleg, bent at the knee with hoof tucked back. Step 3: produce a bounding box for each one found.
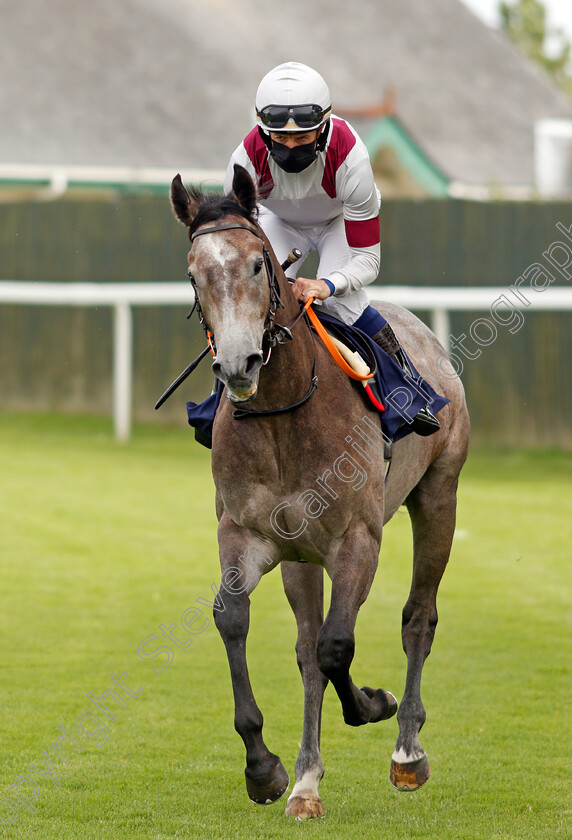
[317,526,397,726]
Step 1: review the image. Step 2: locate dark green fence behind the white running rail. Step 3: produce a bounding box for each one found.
[0,197,572,446]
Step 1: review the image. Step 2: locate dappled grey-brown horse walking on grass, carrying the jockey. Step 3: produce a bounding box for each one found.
[171,167,469,819]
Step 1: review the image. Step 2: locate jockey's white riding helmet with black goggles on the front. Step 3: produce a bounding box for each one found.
[255,61,332,132]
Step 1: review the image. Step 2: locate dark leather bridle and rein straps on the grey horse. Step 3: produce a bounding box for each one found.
[189,223,318,420]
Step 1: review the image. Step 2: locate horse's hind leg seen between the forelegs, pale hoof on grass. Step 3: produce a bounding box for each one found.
[281,562,328,819]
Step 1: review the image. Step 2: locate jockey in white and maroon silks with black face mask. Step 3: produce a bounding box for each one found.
[224,61,440,435]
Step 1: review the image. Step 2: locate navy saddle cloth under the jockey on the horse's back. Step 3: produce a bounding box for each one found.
[187,307,449,449]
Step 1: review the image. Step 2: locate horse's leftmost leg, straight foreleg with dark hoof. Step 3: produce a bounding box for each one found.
[214,526,289,805]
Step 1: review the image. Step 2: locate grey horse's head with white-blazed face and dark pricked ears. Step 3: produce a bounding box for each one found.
[171,165,279,403]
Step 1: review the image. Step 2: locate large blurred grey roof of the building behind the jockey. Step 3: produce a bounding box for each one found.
[0,0,572,184]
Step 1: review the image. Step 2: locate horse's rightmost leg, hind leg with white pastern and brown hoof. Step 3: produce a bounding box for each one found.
[389,471,457,791]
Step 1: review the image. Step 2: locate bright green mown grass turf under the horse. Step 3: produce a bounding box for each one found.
[0,414,572,840]
